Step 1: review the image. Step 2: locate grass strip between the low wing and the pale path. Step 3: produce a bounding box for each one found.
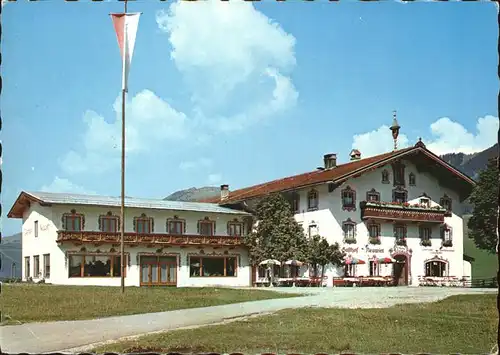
[1,284,301,324]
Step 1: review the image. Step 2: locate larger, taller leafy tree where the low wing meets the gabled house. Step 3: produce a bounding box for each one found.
[244,194,307,265]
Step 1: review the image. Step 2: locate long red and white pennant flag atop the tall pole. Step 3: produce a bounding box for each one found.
[111,12,141,91]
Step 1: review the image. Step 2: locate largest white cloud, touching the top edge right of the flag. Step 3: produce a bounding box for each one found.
[156,0,298,132]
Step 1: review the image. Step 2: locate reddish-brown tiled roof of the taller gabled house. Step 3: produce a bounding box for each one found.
[199,143,474,204]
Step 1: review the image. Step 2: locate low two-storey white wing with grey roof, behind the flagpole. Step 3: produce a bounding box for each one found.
[8,192,251,286]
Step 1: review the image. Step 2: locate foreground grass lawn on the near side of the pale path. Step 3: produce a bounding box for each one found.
[93,295,498,354]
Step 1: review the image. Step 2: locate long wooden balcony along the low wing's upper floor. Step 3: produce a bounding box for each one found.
[57,231,243,246]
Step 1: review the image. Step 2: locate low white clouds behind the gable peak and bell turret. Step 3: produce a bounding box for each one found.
[352,116,498,157]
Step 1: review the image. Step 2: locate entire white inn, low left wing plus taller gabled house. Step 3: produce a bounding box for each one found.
[8,135,474,286]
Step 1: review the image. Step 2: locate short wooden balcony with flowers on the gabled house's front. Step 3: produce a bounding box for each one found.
[360,201,447,223]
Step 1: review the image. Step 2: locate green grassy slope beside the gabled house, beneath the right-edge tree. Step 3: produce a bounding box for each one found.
[464,215,498,279]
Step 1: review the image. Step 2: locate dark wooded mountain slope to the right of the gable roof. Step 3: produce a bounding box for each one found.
[441,144,498,179]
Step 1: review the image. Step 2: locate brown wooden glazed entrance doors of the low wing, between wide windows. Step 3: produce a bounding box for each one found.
[140,256,177,286]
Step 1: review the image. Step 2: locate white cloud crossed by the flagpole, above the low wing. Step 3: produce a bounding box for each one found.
[59,90,190,175]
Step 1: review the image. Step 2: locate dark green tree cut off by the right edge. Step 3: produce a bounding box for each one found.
[467,160,499,254]
